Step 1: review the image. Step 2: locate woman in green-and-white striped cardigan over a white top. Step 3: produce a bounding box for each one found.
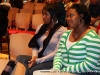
[53,4,100,75]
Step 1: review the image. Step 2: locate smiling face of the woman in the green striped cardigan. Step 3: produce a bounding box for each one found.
[66,9,80,29]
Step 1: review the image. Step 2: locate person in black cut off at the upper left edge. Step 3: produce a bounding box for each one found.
[0,3,10,38]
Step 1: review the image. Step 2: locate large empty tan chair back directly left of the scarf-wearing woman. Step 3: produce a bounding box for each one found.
[10,33,33,58]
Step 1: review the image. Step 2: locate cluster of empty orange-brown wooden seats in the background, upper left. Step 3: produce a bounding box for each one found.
[8,2,45,29]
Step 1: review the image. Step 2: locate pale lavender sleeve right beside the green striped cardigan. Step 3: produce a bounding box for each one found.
[36,28,67,64]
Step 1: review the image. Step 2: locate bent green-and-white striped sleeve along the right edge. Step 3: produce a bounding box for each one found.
[61,35,100,73]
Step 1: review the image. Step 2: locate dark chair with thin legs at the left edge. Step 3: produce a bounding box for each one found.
[0,31,10,54]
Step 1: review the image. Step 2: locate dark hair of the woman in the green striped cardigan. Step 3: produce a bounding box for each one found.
[69,4,91,25]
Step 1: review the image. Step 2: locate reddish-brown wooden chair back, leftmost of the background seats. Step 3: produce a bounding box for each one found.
[8,7,19,28]
